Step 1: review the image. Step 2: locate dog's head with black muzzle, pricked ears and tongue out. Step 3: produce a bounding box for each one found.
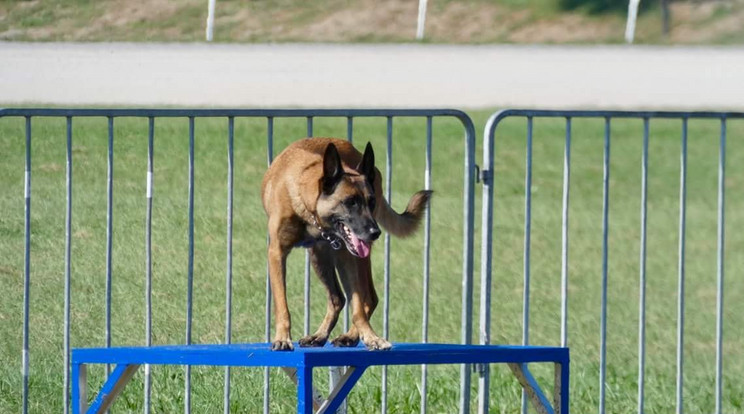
[316,143,380,258]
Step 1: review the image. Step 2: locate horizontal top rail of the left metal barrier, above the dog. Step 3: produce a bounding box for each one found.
[0,108,472,126]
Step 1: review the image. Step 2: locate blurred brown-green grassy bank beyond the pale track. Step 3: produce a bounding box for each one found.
[0,0,744,45]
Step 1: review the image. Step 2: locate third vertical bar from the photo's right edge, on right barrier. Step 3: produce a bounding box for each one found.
[638,118,649,414]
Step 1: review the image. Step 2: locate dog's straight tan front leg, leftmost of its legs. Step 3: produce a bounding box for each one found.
[268,237,293,351]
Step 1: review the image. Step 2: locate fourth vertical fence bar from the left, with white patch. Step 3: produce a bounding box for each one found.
[144,117,155,414]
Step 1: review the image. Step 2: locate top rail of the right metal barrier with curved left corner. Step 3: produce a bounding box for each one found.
[486,109,744,136]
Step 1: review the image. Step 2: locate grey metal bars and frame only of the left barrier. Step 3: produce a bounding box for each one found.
[0,109,475,413]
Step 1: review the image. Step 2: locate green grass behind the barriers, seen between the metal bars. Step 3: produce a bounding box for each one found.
[0,112,744,413]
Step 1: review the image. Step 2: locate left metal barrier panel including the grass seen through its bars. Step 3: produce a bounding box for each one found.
[0,109,475,412]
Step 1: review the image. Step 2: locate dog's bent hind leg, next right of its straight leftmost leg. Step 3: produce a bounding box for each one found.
[299,242,345,346]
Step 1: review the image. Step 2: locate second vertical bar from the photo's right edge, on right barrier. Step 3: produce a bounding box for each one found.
[676,118,687,414]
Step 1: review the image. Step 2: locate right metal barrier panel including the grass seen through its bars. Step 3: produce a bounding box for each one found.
[479,110,744,413]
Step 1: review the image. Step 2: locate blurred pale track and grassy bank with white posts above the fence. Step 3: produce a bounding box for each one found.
[0,0,744,110]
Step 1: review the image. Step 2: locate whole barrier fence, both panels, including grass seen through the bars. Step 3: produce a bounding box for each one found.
[0,109,744,412]
